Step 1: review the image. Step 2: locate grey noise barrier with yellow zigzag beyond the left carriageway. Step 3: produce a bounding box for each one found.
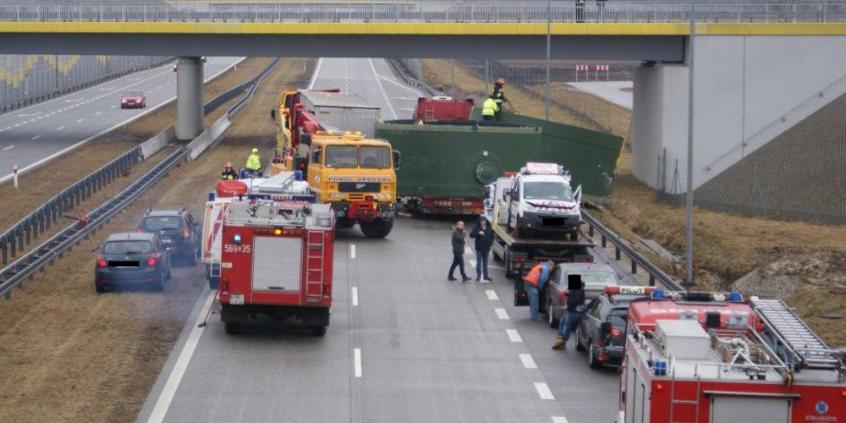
[0,55,171,113]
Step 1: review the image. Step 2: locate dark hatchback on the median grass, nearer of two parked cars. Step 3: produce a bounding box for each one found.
[94,232,170,292]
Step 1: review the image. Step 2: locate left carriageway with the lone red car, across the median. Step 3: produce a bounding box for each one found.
[0,57,243,180]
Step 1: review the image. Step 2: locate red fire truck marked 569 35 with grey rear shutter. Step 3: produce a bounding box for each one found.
[219,199,334,336]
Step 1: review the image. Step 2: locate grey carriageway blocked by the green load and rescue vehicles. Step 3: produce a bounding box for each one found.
[137,59,619,423]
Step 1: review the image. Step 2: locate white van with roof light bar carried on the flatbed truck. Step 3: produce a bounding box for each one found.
[500,162,582,240]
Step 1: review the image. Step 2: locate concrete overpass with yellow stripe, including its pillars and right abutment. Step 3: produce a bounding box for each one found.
[0,1,846,187]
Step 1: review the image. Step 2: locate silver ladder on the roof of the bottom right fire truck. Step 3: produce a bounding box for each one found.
[750,298,842,372]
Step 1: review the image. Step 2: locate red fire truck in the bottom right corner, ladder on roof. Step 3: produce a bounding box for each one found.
[617,290,846,423]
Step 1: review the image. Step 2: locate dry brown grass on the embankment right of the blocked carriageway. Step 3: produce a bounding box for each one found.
[424,60,846,346]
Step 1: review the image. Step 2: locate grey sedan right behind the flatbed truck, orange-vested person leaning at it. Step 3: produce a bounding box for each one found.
[541,263,620,328]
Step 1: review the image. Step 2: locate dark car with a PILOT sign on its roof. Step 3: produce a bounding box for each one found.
[576,286,651,369]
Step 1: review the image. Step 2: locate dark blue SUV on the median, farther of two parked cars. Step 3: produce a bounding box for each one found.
[138,209,200,266]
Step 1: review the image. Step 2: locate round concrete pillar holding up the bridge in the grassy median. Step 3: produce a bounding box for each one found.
[176,57,203,140]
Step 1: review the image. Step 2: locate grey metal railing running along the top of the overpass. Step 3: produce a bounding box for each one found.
[0,0,846,23]
